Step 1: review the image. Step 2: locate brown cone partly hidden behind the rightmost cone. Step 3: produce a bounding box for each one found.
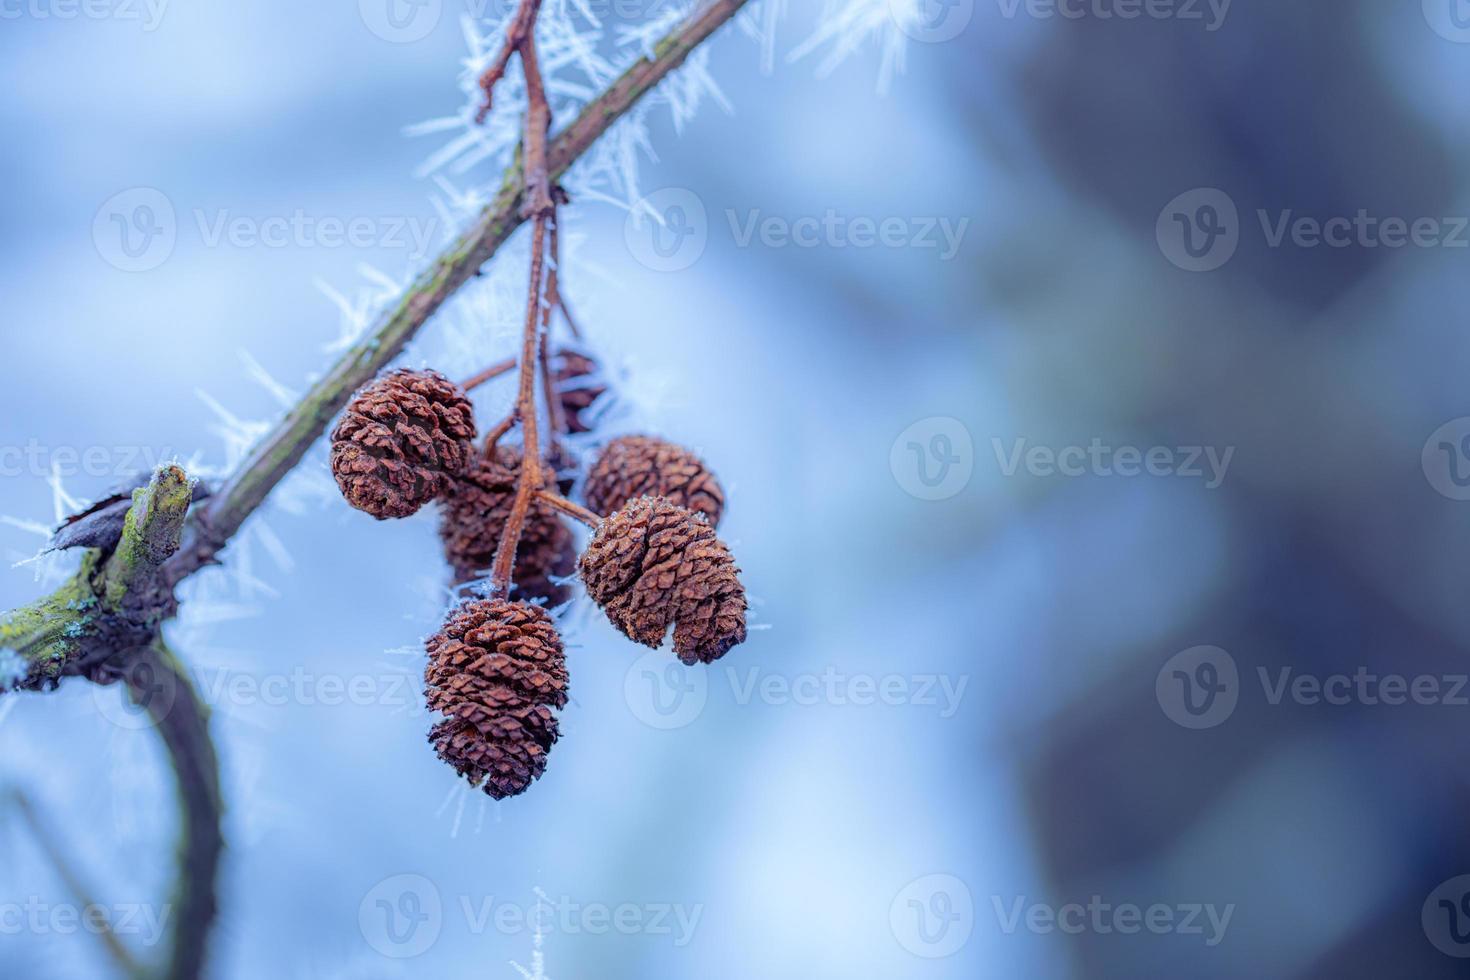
[585,435,725,527]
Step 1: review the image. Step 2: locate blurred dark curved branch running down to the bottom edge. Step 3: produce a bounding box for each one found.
[125,638,225,980]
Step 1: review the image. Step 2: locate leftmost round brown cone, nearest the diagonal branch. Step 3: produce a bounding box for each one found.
[332,369,475,520]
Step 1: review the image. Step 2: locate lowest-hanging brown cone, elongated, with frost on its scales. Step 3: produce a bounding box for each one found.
[423,599,567,799]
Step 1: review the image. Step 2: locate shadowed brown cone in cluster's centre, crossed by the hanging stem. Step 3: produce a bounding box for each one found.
[440,445,576,605]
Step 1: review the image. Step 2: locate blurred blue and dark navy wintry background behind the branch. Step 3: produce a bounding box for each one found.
[0,0,1470,980]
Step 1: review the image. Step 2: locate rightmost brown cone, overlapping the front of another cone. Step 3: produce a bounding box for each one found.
[579,497,745,664]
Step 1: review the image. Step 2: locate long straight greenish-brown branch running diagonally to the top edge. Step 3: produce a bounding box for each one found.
[169,0,750,582]
